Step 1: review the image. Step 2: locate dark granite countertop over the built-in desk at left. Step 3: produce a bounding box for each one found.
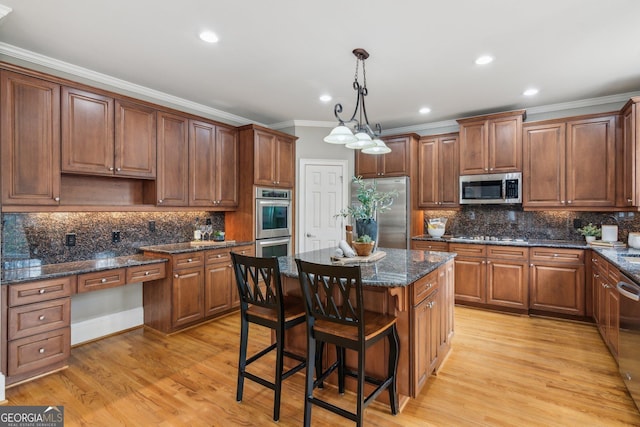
[2,255,167,285]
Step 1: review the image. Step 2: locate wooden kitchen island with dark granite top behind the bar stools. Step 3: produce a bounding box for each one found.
[279,248,456,410]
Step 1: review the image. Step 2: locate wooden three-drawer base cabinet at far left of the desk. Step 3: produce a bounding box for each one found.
[3,276,75,384]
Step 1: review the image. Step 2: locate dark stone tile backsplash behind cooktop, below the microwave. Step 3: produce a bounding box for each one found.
[424,206,640,242]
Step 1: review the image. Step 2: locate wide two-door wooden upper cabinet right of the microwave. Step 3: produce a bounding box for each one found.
[523,114,616,209]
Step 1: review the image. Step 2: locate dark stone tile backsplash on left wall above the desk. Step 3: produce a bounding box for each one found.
[2,212,224,268]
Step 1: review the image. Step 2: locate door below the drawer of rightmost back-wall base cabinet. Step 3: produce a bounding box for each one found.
[529,264,585,316]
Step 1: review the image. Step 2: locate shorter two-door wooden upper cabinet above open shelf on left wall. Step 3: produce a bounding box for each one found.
[61,87,156,179]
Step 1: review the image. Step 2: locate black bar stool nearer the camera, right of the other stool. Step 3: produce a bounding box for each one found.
[296,259,400,427]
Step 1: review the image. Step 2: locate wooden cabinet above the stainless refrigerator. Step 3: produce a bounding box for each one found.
[355,134,420,178]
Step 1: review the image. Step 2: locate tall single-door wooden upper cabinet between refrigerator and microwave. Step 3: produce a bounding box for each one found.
[417,133,459,209]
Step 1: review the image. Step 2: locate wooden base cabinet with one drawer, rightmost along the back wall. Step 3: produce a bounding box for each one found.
[529,247,585,316]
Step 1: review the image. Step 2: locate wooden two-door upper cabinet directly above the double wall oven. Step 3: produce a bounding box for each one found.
[240,125,297,188]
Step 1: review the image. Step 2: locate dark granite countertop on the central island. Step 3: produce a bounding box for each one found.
[278,248,456,287]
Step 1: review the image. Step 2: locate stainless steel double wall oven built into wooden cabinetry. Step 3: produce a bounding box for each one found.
[256,187,293,257]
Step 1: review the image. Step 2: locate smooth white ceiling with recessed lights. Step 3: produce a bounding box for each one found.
[0,0,640,129]
